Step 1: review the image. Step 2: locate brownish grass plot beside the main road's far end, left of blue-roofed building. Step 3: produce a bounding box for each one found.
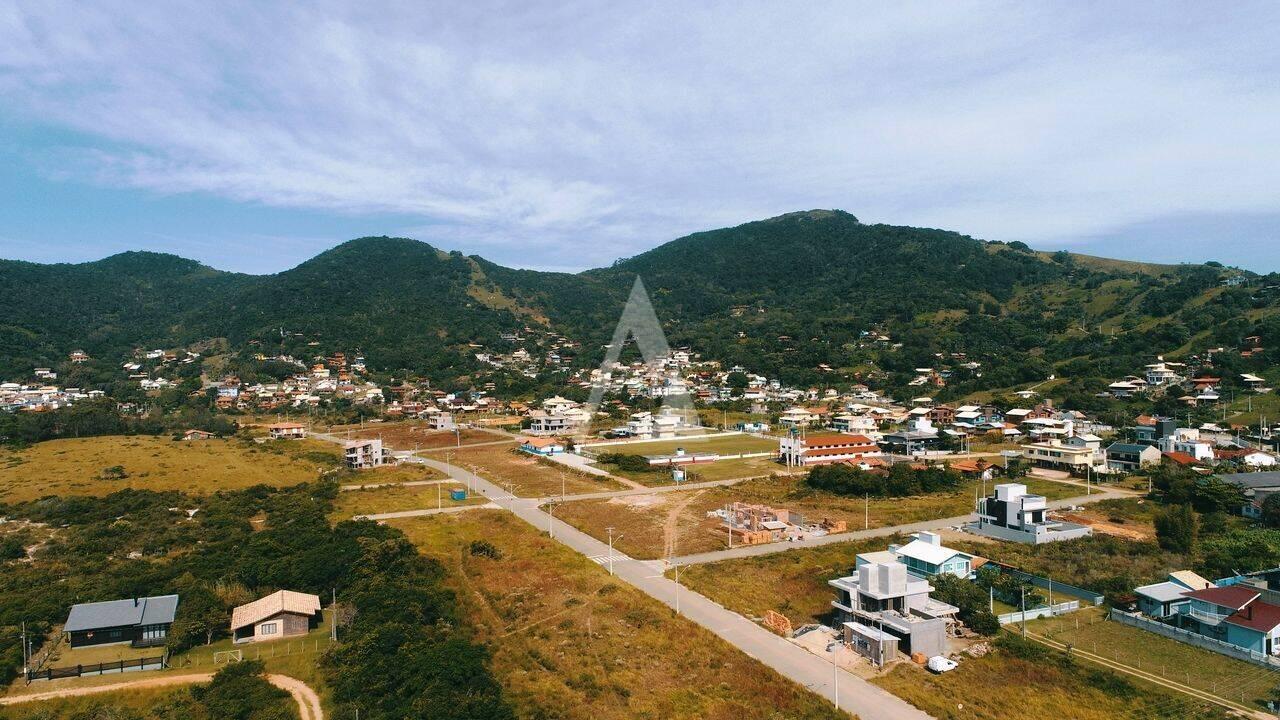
[448,442,625,497]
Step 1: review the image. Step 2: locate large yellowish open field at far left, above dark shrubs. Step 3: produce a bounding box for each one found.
[0,436,342,502]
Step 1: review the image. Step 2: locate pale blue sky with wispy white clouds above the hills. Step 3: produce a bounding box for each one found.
[0,0,1280,273]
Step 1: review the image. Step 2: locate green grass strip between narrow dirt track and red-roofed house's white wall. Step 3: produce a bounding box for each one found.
[1027,607,1280,705]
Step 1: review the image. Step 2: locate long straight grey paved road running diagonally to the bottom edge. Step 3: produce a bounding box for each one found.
[401,457,929,720]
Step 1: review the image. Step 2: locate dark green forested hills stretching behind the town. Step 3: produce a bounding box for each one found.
[0,210,1280,388]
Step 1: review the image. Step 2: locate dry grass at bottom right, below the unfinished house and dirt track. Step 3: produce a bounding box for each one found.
[872,638,1226,720]
